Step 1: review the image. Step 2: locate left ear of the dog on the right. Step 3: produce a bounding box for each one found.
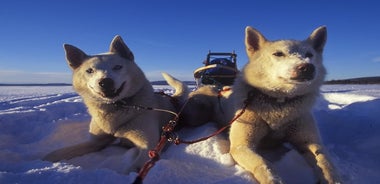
[245,26,266,55]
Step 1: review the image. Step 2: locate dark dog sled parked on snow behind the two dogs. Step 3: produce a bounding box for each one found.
[194,51,238,88]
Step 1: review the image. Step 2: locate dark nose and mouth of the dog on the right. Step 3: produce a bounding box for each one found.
[290,63,315,82]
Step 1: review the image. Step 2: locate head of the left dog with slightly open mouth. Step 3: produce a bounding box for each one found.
[64,36,144,102]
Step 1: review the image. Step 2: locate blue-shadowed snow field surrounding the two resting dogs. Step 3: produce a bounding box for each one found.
[0,85,380,184]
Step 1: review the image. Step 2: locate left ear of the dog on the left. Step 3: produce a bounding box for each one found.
[63,44,89,69]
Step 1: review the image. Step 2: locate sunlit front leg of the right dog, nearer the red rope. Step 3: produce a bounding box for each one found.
[230,119,282,184]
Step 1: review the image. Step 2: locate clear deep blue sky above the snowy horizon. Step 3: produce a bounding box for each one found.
[0,0,380,83]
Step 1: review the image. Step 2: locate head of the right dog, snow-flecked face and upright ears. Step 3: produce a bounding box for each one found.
[243,26,327,97]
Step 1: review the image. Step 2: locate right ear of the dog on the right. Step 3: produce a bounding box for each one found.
[307,26,327,52]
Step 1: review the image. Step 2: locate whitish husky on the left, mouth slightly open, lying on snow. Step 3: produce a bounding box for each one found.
[44,36,188,172]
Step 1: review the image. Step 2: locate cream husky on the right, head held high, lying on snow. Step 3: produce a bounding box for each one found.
[183,27,340,183]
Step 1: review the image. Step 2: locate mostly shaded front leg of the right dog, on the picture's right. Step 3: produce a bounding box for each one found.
[289,115,341,184]
